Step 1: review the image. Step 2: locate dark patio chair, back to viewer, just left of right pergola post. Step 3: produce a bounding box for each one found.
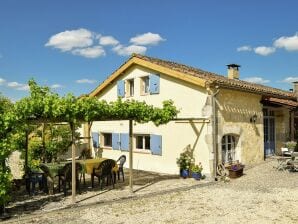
[91,159,116,189]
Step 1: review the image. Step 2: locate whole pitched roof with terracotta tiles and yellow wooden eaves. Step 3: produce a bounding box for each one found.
[90,54,297,101]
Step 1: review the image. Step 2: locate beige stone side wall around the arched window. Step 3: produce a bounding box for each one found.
[217,89,264,164]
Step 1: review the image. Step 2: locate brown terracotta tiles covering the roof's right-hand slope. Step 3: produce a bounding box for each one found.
[132,54,297,100]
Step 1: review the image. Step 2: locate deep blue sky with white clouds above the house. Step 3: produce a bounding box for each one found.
[0,0,298,100]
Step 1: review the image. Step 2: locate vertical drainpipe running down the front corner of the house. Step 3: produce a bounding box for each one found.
[211,86,219,180]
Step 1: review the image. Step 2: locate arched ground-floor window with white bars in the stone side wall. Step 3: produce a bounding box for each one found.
[221,135,236,163]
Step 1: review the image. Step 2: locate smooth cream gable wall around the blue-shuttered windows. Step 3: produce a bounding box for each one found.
[92,66,210,174]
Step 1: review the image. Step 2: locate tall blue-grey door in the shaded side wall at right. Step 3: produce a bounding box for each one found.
[263,109,275,157]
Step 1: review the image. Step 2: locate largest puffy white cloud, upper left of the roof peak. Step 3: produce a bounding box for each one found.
[45,29,94,52]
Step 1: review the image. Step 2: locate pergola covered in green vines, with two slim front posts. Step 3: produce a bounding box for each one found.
[15,80,178,203]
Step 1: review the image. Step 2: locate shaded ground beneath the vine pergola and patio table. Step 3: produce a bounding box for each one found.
[6,169,180,217]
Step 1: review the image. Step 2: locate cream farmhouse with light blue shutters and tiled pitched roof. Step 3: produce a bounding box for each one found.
[84,54,298,175]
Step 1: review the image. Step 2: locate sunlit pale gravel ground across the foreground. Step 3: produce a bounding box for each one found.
[4,160,298,224]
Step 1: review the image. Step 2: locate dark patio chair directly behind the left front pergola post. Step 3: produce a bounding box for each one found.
[58,163,82,196]
